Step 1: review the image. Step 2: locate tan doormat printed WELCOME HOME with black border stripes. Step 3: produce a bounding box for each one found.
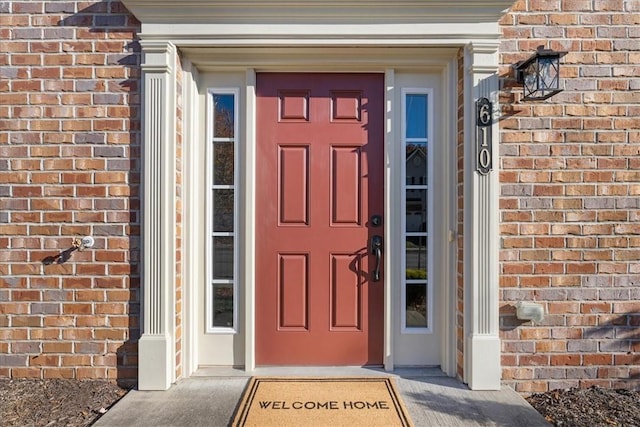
[232,377,413,427]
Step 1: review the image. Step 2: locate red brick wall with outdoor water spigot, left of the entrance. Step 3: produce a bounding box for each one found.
[0,0,141,380]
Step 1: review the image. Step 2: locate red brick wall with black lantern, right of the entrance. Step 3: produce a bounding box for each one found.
[500,0,640,392]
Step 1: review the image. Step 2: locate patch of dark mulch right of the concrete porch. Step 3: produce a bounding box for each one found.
[527,387,640,427]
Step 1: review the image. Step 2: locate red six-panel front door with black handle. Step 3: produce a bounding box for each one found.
[256,73,384,365]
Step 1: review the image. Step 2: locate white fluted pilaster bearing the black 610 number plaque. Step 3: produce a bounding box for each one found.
[463,42,502,390]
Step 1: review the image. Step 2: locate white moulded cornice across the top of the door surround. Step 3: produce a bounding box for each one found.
[123,0,514,45]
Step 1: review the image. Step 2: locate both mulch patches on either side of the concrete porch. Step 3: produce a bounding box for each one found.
[0,379,640,427]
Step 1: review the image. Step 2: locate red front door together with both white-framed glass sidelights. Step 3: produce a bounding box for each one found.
[187,61,456,373]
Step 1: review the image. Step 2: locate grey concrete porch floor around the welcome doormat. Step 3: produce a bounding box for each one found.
[94,367,550,427]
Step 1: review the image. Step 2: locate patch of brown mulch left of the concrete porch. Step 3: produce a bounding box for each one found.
[0,379,128,427]
